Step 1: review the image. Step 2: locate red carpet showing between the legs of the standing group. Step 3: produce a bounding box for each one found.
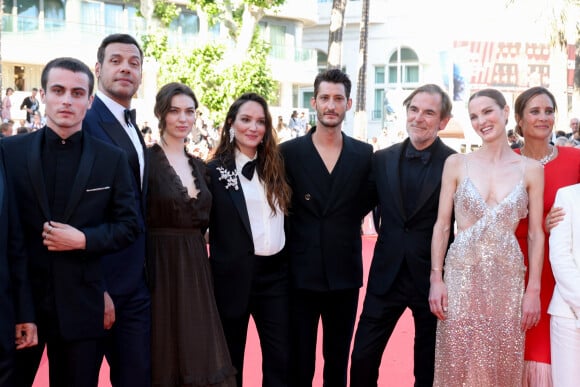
[34,235,415,387]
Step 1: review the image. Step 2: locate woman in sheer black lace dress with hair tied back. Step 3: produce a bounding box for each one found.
[147,83,235,387]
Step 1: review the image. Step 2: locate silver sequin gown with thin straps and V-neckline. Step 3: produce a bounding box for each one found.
[433,177,528,387]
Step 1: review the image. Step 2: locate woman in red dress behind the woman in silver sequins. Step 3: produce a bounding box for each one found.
[514,87,580,387]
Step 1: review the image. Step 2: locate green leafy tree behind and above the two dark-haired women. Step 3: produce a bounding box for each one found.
[140,0,286,122]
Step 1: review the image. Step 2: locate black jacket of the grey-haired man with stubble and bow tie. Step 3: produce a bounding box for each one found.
[367,138,455,297]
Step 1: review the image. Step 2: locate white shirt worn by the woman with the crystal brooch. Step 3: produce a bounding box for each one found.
[236,149,286,256]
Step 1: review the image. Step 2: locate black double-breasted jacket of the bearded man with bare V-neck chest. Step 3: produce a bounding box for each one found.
[280,128,373,291]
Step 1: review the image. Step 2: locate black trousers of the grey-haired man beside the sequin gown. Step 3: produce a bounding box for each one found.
[350,263,437,387]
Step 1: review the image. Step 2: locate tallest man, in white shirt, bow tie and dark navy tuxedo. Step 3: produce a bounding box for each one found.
[83,34,151,387]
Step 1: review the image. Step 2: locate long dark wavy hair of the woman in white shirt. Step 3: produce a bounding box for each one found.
[212,93,291,215]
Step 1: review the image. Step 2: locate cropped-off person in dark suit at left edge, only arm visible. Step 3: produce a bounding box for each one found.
[0,151,38,387]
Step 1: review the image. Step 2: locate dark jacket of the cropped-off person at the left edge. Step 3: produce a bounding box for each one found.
[0,151,34,358]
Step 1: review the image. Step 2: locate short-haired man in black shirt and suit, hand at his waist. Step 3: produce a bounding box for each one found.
[0,58,137,387]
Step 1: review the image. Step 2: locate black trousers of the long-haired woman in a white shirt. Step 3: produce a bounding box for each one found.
[220,253,289,387]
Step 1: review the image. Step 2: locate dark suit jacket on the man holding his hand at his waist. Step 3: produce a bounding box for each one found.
[0,127,137,340]
